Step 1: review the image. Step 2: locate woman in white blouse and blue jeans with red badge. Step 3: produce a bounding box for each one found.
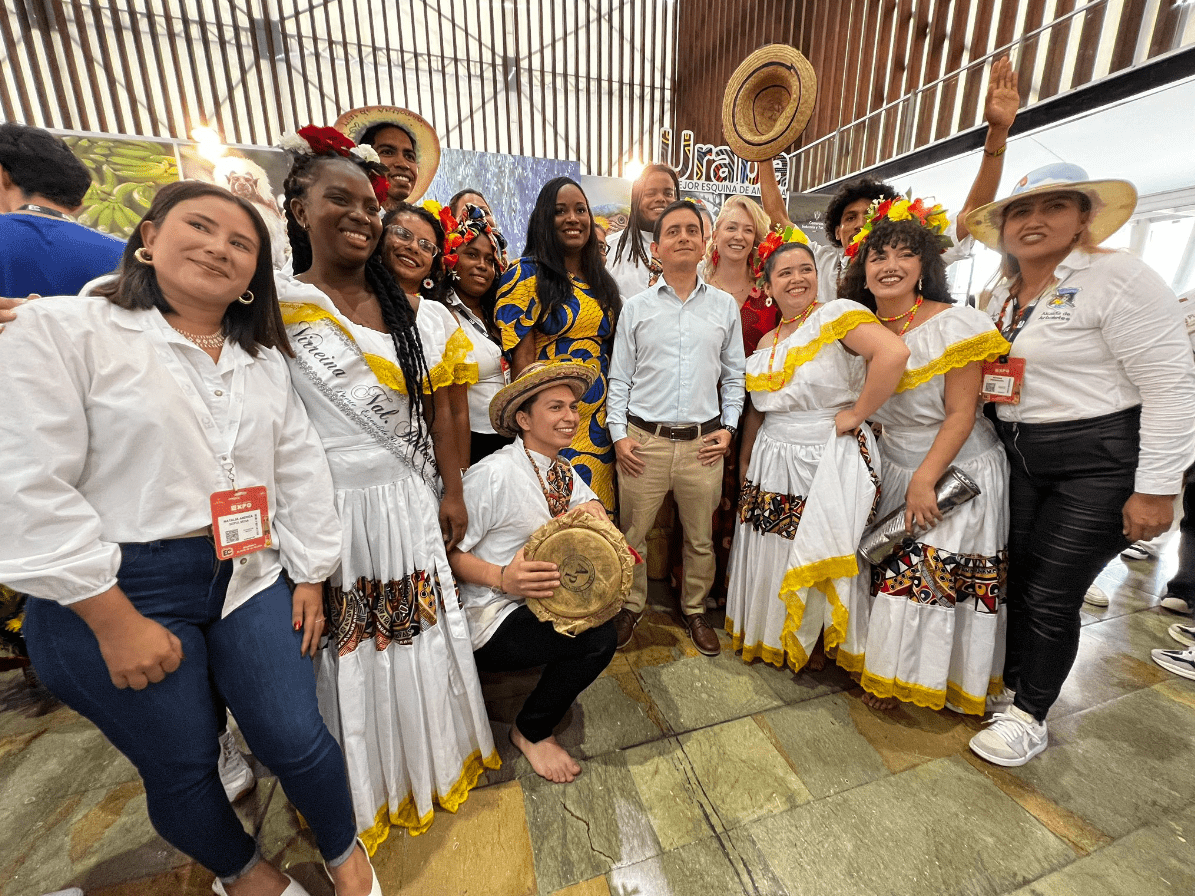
[0,182,379,896]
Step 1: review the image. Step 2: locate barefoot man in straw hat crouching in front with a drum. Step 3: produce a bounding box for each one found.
[448,361,621,784]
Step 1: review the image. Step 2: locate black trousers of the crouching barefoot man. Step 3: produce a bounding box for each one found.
[473,607,618,743]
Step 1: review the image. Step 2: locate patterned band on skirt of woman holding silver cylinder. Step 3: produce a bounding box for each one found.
[871,541,1009,613]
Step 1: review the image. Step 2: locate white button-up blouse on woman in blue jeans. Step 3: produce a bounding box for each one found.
[0,296,341,615]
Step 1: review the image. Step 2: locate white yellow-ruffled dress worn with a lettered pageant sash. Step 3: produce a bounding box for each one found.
[277,277,500,853]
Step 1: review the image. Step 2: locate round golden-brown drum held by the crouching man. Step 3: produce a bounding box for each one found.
[523,510,635,638]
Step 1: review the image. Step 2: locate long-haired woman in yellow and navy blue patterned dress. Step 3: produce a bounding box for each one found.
[495,177,626,515]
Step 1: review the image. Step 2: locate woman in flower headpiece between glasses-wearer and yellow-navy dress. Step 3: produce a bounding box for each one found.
[425,200,513,466]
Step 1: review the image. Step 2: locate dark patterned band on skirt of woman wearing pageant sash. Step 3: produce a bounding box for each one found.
[324,570,441,656]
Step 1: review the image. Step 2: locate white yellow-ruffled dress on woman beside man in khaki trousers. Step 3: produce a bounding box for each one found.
[727,299,880,671]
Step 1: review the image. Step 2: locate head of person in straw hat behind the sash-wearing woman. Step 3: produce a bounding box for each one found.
[333,106,440,210]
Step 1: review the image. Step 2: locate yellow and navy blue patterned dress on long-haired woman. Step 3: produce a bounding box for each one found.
[494,258,614,514]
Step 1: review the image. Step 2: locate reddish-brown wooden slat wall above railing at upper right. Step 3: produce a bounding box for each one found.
[674,0,1195,190]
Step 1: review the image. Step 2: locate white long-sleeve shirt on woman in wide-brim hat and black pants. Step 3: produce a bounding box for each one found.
[988,248,1195,495]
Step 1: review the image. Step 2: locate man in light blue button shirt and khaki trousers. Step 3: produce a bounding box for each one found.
[606,201,746,656]
